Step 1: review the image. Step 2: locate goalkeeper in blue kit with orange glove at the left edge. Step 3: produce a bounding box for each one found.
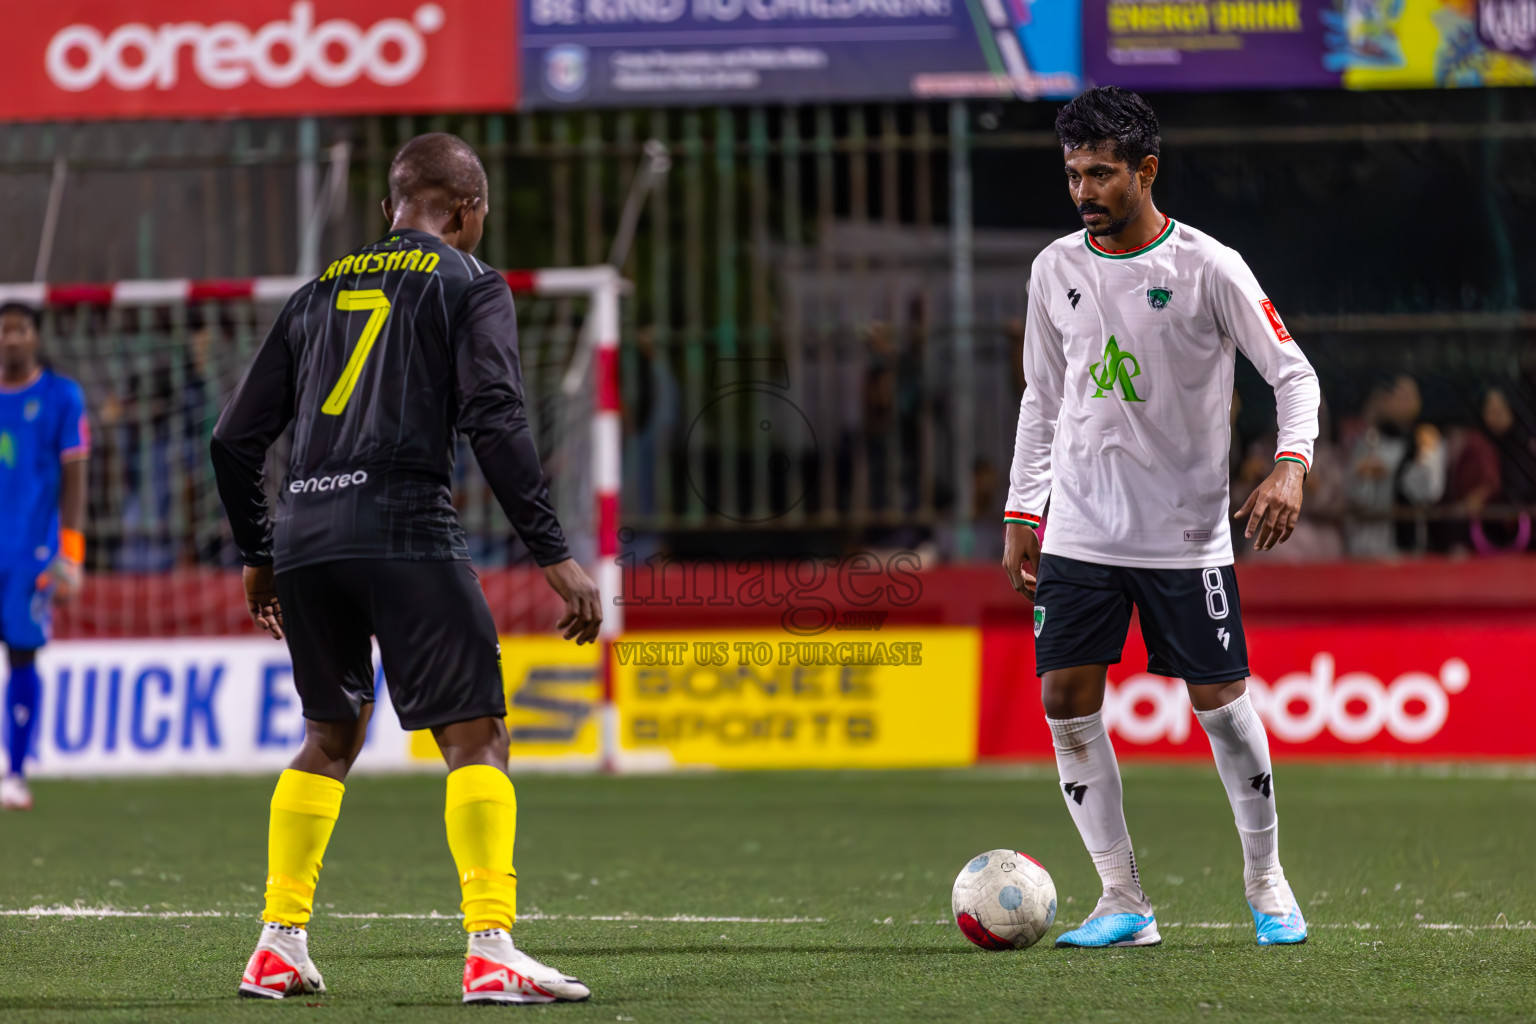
[0,302,91,811]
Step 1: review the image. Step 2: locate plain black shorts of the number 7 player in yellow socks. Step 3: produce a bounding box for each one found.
[276,559,507,729]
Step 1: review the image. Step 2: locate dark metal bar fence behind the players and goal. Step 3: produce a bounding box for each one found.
[0,94,1536,570]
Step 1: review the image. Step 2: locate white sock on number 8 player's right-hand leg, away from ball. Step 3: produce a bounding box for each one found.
[1195,694,1284,909]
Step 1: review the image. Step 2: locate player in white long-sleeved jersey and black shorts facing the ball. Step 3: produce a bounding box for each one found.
[1003,88,1318,946]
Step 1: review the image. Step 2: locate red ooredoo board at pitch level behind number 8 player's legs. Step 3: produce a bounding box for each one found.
[978,616,1536,758]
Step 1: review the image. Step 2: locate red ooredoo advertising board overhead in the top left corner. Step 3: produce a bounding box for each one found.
[0,0,518,120]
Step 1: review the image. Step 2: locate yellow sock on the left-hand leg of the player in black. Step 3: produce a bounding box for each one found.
[261,768,347,927]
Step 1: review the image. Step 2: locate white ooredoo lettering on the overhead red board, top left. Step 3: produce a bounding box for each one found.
[43,0,447,92]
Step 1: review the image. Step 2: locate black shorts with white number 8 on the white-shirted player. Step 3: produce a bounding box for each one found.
[1035,554,1249,683]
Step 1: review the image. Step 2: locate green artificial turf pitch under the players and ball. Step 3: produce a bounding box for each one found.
[0,765,1536,1024]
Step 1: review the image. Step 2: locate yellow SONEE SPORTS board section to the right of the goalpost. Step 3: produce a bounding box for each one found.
[613,626,980,769]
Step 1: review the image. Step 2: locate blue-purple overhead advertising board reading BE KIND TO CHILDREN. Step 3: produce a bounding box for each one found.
[519,0,1083,107]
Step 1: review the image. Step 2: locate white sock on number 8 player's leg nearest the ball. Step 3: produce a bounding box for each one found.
[1046,711,1141,895]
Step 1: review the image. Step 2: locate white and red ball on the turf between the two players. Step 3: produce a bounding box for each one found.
[951,851,1055,949]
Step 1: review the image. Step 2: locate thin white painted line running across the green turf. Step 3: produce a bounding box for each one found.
[0,904,1536,932]
